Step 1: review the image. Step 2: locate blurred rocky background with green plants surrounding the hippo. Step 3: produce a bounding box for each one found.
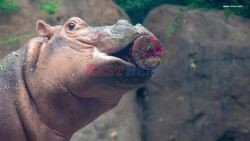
[0,0,250,141]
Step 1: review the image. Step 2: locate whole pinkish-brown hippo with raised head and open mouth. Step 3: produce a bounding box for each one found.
[0,17,162,141]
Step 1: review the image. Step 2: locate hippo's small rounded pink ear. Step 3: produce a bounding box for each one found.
[36,20,54,38]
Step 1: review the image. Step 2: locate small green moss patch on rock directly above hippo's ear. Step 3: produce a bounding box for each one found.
[39,0,62,15]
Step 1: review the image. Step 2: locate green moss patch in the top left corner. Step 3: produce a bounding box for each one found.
[0,0,18,13]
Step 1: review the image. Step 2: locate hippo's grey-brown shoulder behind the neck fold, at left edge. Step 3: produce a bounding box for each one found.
[0,47,26,141]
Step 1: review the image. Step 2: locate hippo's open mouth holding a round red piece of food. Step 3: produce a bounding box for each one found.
[111,35,163,70]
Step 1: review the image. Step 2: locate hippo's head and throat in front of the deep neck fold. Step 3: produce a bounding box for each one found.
[25,17,161,137]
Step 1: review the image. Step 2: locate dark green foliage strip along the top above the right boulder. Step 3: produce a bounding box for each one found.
[113,0,250,23]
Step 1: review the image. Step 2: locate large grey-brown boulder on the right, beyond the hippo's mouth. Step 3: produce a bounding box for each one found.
[141,5,250,141]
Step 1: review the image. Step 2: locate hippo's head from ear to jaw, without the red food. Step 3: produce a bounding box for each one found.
[26,17,162,103]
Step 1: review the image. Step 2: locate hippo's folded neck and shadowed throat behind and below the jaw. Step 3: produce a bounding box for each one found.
[20,38,114,141]
